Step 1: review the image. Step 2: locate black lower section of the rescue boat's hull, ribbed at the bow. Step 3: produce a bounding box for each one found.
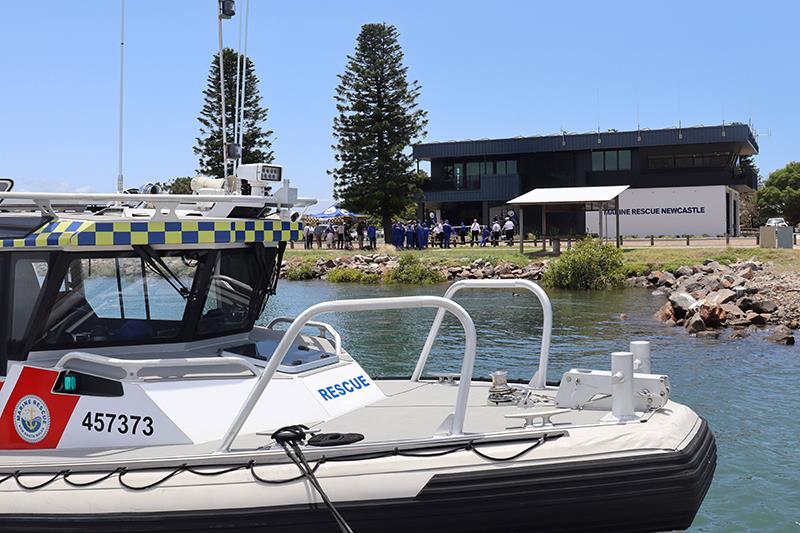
[0,422,716,533]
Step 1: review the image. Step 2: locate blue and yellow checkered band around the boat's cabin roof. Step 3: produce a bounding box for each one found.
[0,220,302,248]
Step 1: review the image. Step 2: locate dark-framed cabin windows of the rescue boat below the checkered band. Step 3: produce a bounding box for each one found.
[21,246,281,357]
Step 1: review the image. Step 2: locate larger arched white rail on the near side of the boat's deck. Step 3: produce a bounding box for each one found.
[217,296,477,453]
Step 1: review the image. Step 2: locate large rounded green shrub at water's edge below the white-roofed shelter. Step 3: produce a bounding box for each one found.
[542,239,625,289]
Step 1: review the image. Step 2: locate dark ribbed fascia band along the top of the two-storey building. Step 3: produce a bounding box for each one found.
[414,124,758,159]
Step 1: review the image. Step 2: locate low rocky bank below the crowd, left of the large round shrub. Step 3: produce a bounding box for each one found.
[281,254,545,281]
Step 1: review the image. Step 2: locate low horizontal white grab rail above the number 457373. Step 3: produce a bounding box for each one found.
[55,352,258,379]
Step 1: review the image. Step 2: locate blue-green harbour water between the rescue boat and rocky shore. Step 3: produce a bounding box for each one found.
[262,281,800,532]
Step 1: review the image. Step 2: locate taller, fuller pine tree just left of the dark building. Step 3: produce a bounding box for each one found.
[329,24,428,238]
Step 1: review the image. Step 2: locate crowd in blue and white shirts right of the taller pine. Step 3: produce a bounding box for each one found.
[392,217,517,250]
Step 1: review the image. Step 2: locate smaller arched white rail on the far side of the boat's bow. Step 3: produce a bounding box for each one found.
[411,279,553,389]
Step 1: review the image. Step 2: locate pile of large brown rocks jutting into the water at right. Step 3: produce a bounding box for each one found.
[628,260,800,344]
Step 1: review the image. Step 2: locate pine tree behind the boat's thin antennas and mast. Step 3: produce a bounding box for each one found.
[194,48,274,178]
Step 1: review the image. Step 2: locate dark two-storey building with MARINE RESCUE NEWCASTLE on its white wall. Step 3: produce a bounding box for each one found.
[413,123,758,235]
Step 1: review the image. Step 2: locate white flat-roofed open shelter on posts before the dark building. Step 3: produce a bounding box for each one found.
[507,185,630,252]
